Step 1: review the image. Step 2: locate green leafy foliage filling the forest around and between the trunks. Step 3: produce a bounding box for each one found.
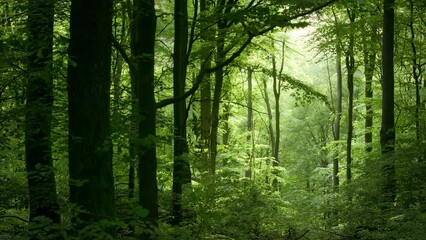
[0,0,426,240]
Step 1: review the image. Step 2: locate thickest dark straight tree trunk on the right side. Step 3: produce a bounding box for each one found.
[380,0,396,204]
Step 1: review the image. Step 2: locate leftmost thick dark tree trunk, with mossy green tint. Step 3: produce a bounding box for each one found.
[25,0,61,239]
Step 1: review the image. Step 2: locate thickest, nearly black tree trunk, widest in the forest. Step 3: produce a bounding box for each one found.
[68,0,114,233]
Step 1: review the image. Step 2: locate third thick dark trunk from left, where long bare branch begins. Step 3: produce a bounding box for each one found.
[131,0,158,232]
